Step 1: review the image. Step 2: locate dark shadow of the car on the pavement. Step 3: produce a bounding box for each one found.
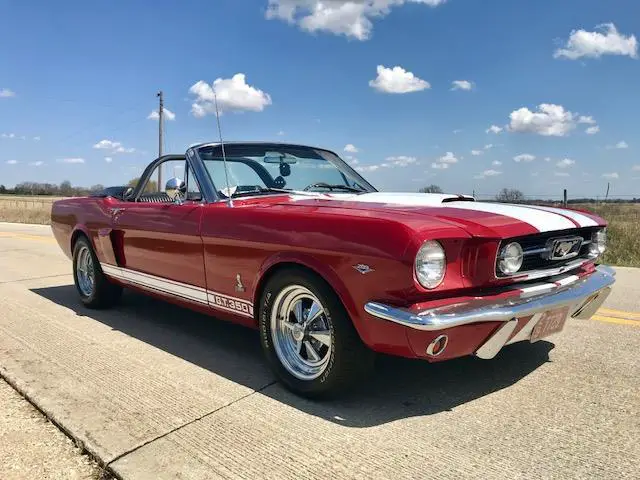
[32,285,554,428]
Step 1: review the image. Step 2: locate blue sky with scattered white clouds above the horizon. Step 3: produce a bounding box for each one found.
[0,0,640,196]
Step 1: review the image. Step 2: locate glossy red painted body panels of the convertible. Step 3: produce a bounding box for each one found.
[52,189,605,361]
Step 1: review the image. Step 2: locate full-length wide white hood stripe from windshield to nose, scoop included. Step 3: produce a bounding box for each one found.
[299,192,580,232]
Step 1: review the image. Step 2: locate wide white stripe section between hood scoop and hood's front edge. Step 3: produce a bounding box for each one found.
[442,202,576,232]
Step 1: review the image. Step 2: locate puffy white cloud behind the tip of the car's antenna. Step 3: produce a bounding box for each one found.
[189,73,272,118]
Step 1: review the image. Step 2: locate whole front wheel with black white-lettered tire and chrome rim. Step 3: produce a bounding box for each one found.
[259,268,374,397]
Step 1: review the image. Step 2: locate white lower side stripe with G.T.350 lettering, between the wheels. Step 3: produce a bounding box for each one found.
[100,263,253,317]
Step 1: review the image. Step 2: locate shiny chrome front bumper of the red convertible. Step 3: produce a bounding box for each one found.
[364,265,615,332]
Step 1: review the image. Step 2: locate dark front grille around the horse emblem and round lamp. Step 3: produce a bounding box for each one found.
[495,227,598,278]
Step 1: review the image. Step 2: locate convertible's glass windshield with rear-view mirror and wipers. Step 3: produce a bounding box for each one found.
[198,144,375,197]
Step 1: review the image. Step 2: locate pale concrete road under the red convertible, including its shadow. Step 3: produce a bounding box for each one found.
[0,224,640,480]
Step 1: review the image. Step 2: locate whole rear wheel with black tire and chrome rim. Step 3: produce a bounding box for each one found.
[73,235,122,309]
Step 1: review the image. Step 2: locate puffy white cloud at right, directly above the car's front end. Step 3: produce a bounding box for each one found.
[508,103,576,137]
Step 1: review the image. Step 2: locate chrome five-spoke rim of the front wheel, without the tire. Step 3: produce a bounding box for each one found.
[270,285,333,380]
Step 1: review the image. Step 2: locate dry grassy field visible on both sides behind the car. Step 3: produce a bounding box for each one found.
[0,195,640,267]
